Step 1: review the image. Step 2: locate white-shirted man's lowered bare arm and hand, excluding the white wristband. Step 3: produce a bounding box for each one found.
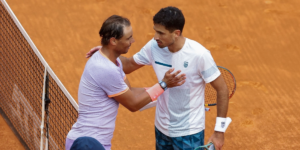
[208,75,229,150]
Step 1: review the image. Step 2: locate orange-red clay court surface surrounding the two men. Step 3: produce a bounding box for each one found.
[0,0,300,150]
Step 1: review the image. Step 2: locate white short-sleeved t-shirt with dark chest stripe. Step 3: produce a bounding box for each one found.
[133,38,221,137]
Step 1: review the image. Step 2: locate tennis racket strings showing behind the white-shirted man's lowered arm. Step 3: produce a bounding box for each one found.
[204,66,236,106]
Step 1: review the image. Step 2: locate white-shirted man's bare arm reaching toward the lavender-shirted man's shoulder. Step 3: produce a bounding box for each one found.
[119,56,144,74]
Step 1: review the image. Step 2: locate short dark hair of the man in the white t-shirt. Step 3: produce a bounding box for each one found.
[153,6,185,33]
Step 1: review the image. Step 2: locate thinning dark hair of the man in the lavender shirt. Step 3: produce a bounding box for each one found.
[99,15,130,45]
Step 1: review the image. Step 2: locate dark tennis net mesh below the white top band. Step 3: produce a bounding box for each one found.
[0,1,78,150]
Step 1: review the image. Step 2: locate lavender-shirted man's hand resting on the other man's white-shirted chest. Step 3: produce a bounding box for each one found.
[162,68,186,88]
